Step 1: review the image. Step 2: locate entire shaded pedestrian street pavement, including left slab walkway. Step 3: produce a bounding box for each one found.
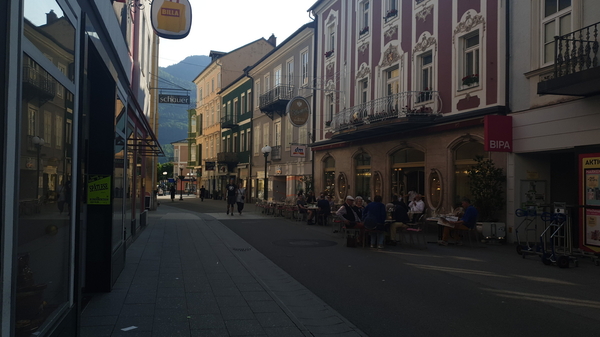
[82,196,600,336]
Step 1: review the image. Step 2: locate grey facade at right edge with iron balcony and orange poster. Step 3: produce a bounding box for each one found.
[507,0,600,244]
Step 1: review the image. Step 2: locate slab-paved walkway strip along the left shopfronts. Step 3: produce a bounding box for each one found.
[81,196,365,337]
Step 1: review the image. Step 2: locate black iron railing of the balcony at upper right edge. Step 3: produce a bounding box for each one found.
[554,22,600,78]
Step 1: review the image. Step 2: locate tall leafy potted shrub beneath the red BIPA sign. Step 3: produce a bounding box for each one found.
[467,156,506,242]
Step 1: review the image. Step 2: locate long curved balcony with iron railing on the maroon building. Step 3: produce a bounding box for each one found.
[329,91,442,140]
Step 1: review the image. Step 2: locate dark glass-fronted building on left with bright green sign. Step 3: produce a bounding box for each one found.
[0,0,162,336]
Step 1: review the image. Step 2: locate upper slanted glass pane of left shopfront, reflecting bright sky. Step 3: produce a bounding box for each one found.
[23,0,75,82]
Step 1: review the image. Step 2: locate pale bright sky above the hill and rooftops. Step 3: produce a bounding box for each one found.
[158,0,317,67]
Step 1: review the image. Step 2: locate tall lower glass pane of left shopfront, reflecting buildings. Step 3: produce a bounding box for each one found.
[15,54,73,335]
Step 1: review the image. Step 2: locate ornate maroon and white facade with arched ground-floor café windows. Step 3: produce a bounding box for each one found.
[309,0,506,213]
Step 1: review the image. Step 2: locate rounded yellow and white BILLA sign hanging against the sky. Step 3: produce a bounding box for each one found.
[150,0,192,39]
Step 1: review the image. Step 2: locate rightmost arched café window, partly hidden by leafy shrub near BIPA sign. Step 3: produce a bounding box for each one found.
[452,141,487,203]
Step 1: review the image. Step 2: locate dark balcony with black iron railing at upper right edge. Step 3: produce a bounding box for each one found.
[537,22,600,96]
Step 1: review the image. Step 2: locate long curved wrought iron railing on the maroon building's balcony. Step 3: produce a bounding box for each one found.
[330,91,442,131]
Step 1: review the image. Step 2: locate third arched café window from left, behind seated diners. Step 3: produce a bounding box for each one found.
[390,148,425,198]
